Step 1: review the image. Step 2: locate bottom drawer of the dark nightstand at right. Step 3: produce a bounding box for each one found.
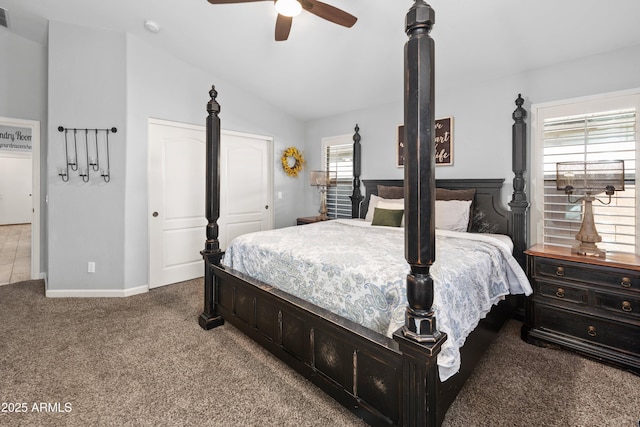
[536,304,640,354]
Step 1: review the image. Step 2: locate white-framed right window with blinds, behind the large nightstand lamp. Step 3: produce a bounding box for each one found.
[532,93,640,253]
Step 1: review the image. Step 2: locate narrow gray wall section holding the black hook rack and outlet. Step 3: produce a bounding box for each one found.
[47,21,128,291]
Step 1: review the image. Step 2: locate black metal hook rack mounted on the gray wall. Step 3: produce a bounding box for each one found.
[58,126,118,182]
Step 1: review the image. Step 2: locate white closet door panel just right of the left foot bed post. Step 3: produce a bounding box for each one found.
[218,130,273,250]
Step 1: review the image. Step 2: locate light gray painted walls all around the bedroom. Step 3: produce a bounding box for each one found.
[5,17,640,290]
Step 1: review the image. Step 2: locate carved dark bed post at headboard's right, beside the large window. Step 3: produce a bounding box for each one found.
[509,94,529,268]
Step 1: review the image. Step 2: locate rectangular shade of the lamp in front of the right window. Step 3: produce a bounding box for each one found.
[556,160,624,194]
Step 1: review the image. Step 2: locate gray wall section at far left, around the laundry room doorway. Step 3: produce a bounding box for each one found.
[0,27,47,272]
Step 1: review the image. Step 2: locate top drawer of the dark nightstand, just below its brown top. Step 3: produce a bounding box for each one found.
[533,257,640,292]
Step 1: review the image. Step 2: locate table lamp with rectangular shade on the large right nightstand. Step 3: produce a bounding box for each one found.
[556,160,624,257]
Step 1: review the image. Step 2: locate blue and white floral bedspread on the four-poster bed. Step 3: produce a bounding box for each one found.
[223,220,532,381]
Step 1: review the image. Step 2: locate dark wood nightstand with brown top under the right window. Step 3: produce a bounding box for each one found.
[522,245,640,375]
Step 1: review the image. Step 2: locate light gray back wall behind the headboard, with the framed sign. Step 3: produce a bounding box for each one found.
[305,43,640,216]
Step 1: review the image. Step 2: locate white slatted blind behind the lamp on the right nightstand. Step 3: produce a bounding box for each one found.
[541,108,639,253]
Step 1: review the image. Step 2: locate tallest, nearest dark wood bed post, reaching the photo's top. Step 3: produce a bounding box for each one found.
[393,0,447,426]
